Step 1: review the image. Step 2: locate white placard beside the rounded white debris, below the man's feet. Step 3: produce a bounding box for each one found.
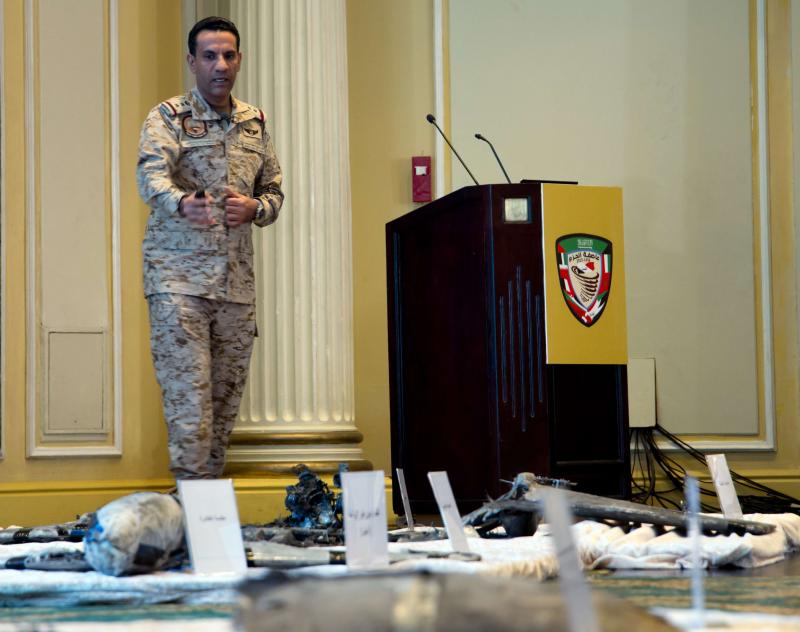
[178,478,247,575]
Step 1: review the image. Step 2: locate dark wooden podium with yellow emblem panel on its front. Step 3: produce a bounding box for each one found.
[386,182,630,514]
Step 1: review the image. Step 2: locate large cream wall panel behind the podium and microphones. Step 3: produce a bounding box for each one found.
[449,0,774,449]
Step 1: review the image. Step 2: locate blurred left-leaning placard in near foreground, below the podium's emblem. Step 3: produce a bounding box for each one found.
[539,487,600,632]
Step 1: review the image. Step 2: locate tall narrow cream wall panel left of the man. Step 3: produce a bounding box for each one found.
[25,0,121,456]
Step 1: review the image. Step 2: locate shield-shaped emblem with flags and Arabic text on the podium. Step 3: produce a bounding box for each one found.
[556,234,611,327]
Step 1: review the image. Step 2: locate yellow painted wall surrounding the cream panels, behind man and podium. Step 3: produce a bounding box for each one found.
[0,0,800,526]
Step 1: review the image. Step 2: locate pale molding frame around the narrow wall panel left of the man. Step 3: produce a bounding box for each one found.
[24,0,122,457]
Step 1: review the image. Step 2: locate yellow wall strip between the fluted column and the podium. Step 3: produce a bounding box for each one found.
[347,0,438,473]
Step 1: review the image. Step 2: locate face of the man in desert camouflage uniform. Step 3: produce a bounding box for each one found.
[187,31,242,107]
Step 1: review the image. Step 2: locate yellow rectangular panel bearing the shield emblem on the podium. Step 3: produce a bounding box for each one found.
[541,184,628,365]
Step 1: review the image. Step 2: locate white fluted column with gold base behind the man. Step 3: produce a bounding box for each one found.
[220,0,371,476]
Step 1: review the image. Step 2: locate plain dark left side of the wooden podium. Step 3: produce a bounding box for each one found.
[387,187,499,514]
